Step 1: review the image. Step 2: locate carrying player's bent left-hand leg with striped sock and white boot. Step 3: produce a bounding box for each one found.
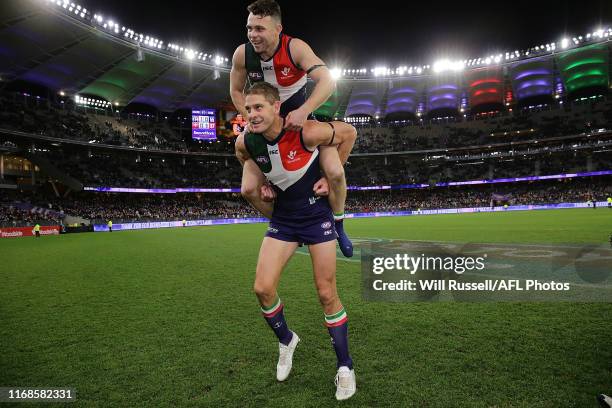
[253,237,300,381]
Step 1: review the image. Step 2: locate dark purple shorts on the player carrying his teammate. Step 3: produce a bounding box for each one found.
[266,212,338,245]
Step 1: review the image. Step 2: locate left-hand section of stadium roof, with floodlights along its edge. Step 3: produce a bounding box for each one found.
[0,0,229,111]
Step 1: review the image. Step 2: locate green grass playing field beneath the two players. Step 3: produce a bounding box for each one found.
[0,208,612,407]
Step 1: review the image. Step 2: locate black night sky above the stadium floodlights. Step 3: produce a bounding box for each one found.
[89,0,612,68]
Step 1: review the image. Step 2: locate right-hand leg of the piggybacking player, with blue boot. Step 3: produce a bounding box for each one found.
[319,146,353,258]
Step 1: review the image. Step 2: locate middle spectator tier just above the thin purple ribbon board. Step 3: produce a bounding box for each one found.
[4,144,612,190]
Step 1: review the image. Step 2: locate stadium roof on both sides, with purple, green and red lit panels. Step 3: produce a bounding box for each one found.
[0,0,611,115]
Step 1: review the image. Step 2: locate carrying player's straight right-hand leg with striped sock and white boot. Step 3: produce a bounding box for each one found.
[309,241,357,400]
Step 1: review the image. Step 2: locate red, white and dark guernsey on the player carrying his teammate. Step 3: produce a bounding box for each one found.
[244,130,330,216]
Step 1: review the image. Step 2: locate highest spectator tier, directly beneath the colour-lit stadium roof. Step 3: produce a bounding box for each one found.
[0,93,612,156]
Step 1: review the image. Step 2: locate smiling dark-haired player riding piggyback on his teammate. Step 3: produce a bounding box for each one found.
[230,0,353,257]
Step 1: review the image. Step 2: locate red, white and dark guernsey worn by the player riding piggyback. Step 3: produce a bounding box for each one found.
[245,33,308,117]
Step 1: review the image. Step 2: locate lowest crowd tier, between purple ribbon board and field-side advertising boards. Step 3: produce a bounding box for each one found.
[0,176,612,227]
